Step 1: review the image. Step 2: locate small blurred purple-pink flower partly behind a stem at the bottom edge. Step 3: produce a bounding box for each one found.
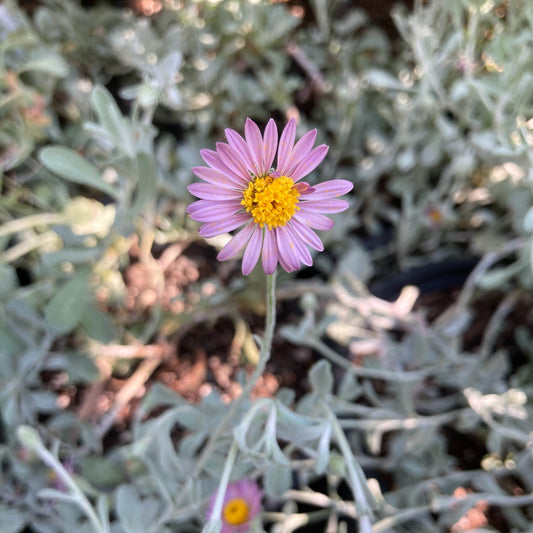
[207,479,263,533]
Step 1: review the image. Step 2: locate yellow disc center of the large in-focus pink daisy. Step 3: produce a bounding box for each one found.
[241,176,300,229]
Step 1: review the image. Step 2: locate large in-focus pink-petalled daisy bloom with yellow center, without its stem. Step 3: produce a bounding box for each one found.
[187,119,353,275]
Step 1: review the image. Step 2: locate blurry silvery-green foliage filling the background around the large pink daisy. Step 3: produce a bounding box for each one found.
[0,0,533,533]
